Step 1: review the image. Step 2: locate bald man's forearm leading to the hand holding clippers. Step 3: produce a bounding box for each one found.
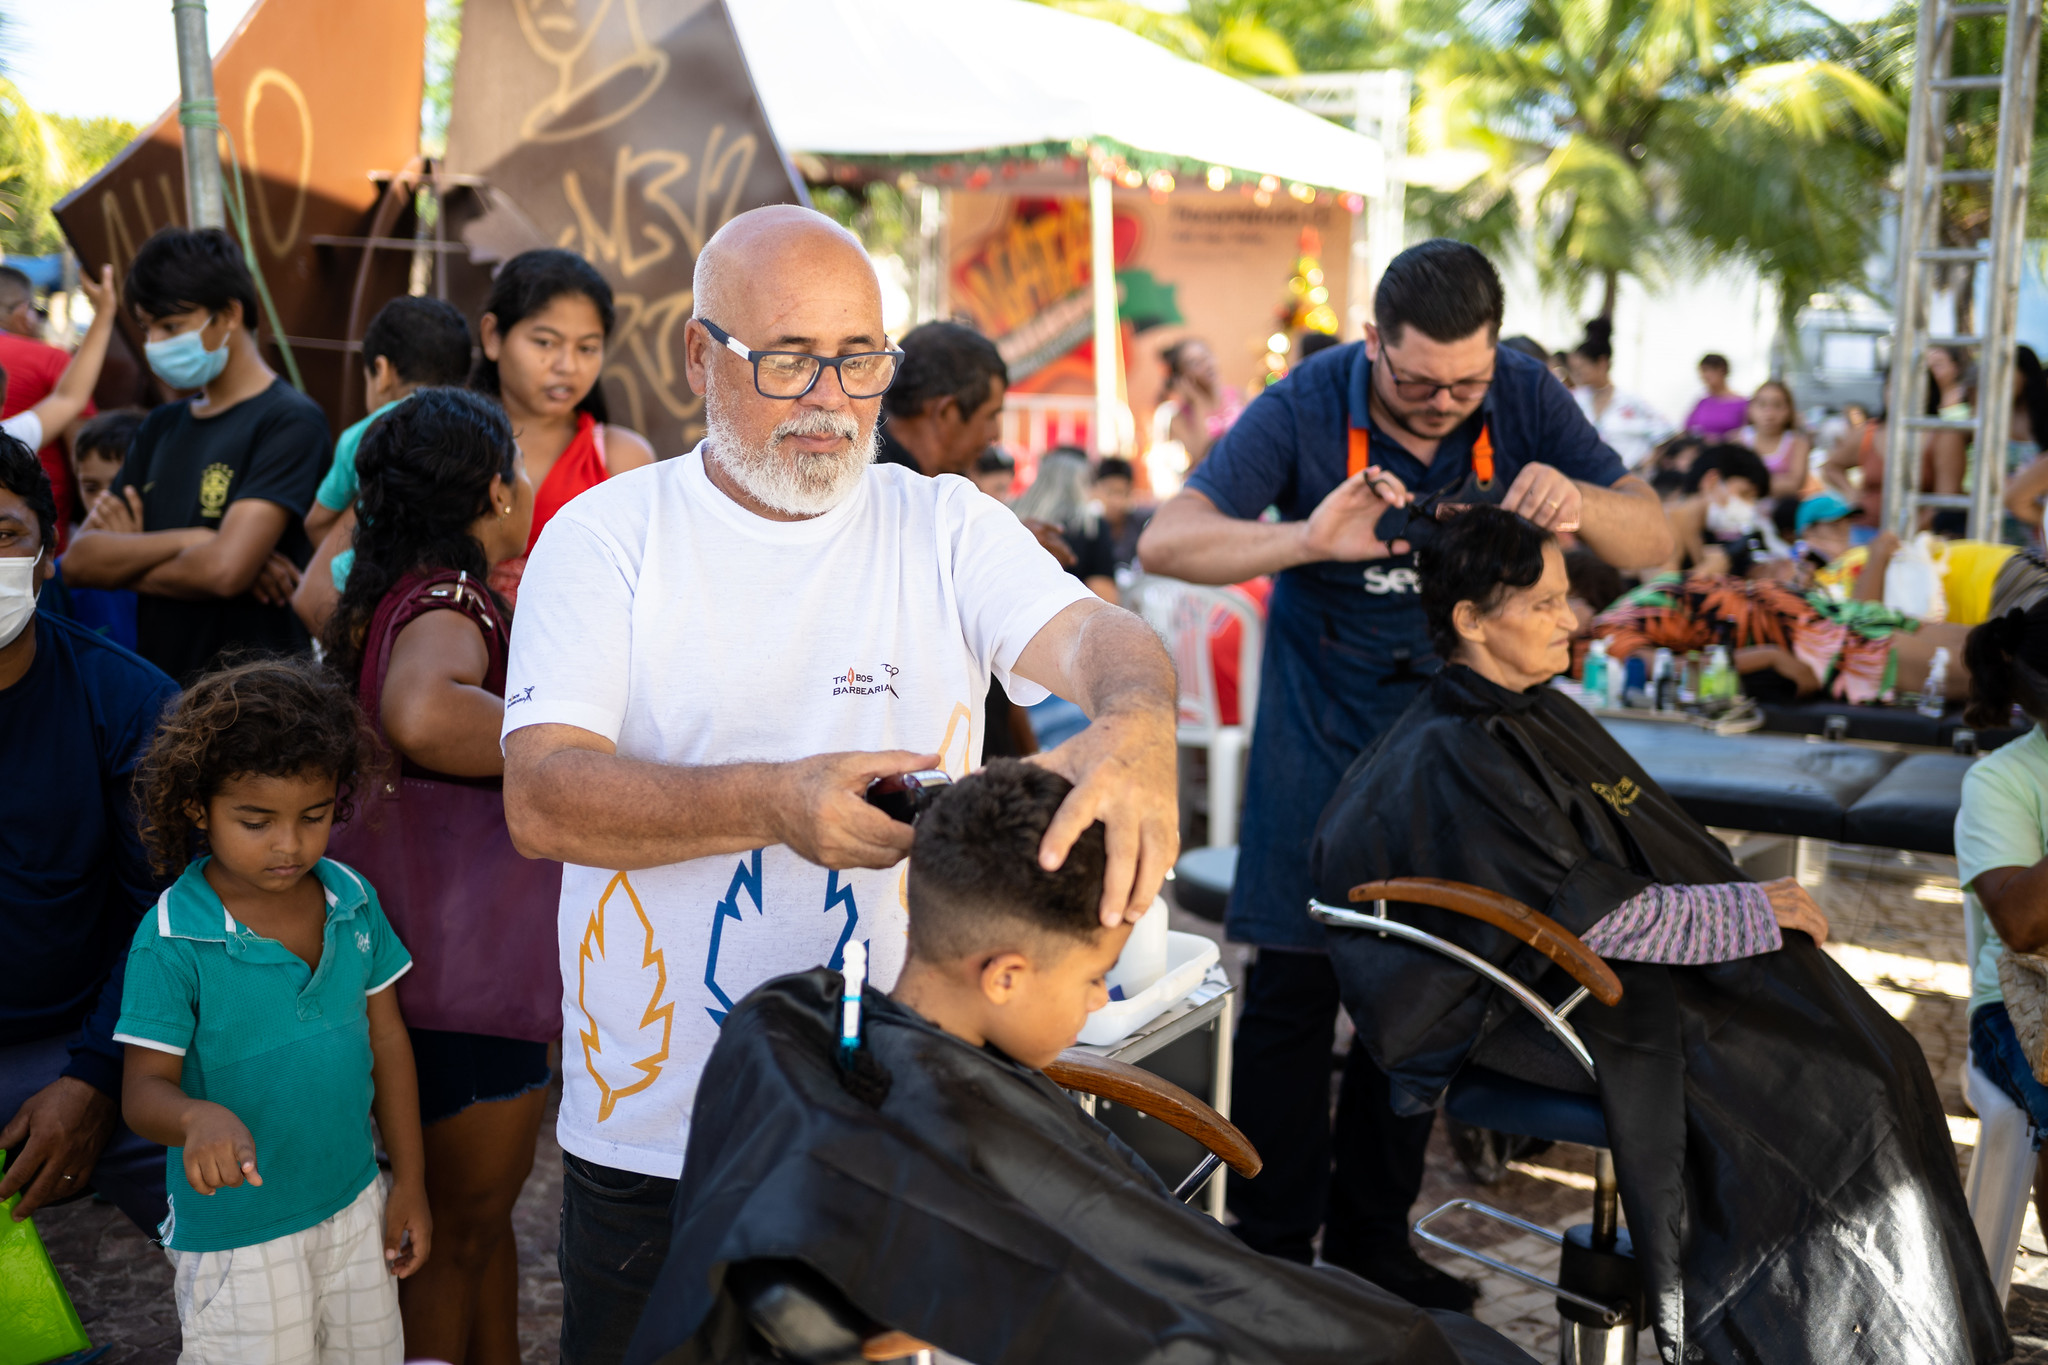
[506,745,784,872]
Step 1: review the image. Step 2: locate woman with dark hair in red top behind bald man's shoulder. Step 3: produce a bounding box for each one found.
[469,248,653,602]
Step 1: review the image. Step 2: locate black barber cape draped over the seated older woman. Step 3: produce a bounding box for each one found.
[1313,665,2011,1365]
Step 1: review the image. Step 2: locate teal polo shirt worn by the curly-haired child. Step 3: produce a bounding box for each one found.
[115,857,412,1250]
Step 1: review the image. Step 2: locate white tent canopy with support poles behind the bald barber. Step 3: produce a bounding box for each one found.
[727,0,1407,444]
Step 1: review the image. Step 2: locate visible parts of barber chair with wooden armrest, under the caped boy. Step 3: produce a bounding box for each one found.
[725,1048,1266,1365]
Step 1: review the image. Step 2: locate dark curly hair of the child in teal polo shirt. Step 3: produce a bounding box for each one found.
[135,659,369,876]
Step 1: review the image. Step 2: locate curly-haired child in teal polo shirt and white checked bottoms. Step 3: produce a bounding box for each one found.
[115,659,430,1365]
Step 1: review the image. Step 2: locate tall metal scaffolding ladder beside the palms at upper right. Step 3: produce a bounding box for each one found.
[1884,0,2042,540]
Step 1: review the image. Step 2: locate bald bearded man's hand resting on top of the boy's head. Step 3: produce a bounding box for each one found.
[1024,710,1180,925]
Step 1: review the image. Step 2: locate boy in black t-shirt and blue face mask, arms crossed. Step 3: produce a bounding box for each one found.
[63,227,328,695]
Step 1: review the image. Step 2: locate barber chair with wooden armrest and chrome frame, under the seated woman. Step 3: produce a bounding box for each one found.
[1309,878,1645,1365]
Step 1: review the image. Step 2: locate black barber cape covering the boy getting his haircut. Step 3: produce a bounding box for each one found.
[627,968,1530,1365]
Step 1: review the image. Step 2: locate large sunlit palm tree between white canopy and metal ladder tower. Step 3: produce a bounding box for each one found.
[1411,0,1905,317]
